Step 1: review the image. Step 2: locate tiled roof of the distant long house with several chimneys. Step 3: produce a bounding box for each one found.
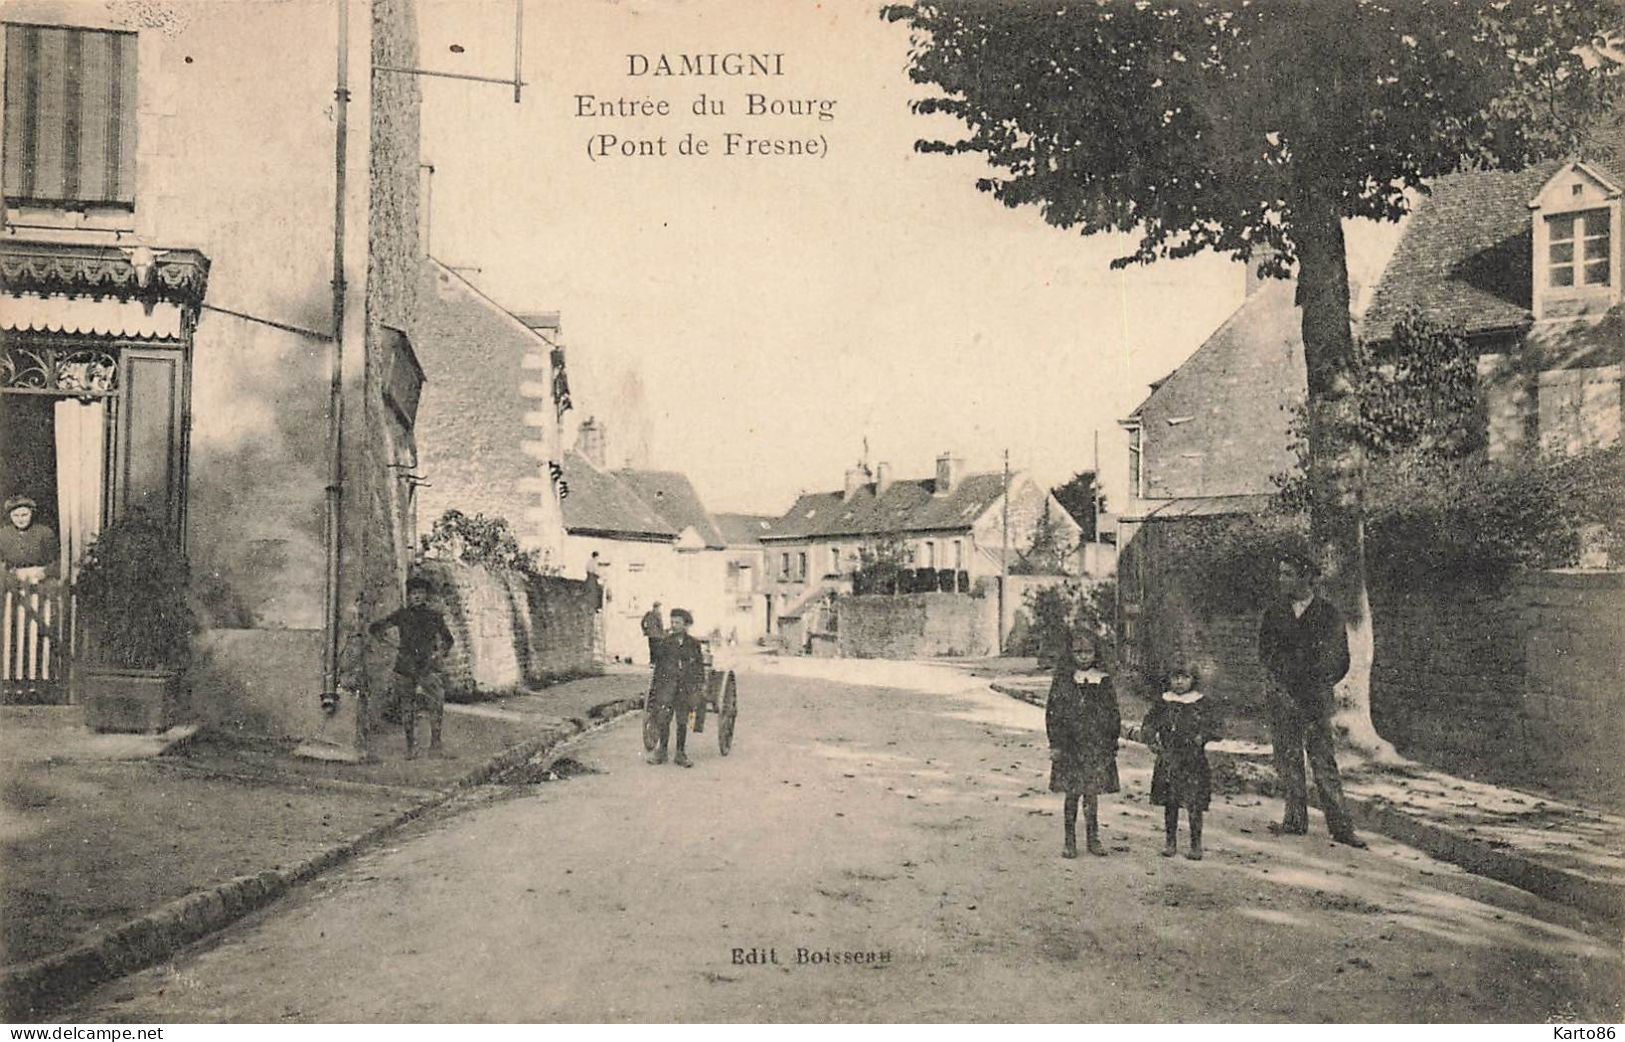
[764,473,1014,540]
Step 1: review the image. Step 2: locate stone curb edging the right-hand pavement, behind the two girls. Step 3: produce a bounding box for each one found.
[988,683,1625,925]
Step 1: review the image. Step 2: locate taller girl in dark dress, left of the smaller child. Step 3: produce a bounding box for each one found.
[1043,634,1121,858]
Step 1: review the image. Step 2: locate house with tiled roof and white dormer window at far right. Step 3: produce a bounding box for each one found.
[1363,161,1625,458]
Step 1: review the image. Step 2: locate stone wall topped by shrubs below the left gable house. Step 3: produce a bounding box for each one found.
[418,561,596,699]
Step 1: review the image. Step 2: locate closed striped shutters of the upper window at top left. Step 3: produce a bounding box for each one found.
[3,23,137,208]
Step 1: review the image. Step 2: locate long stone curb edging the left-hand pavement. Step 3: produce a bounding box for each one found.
[0,699,644,1022]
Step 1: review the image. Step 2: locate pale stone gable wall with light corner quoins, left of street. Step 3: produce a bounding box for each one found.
[413,258,564,566]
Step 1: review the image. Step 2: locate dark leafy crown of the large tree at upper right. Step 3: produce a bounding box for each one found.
[884,0,1620,271]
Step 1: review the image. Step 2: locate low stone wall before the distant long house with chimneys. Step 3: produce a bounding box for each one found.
[835,593,998,658]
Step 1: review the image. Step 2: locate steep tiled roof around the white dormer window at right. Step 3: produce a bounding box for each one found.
[1362,161,1619,340]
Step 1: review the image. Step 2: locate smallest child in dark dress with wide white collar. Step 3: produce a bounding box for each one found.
[1141,666,1217,862]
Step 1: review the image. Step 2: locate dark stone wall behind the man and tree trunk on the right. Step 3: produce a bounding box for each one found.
[1123,536,1625,792]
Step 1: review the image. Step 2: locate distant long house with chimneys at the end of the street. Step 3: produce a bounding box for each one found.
[762,454,1082,633]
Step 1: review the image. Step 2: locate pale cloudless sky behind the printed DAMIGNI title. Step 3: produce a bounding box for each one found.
[419,0,1398,514]
